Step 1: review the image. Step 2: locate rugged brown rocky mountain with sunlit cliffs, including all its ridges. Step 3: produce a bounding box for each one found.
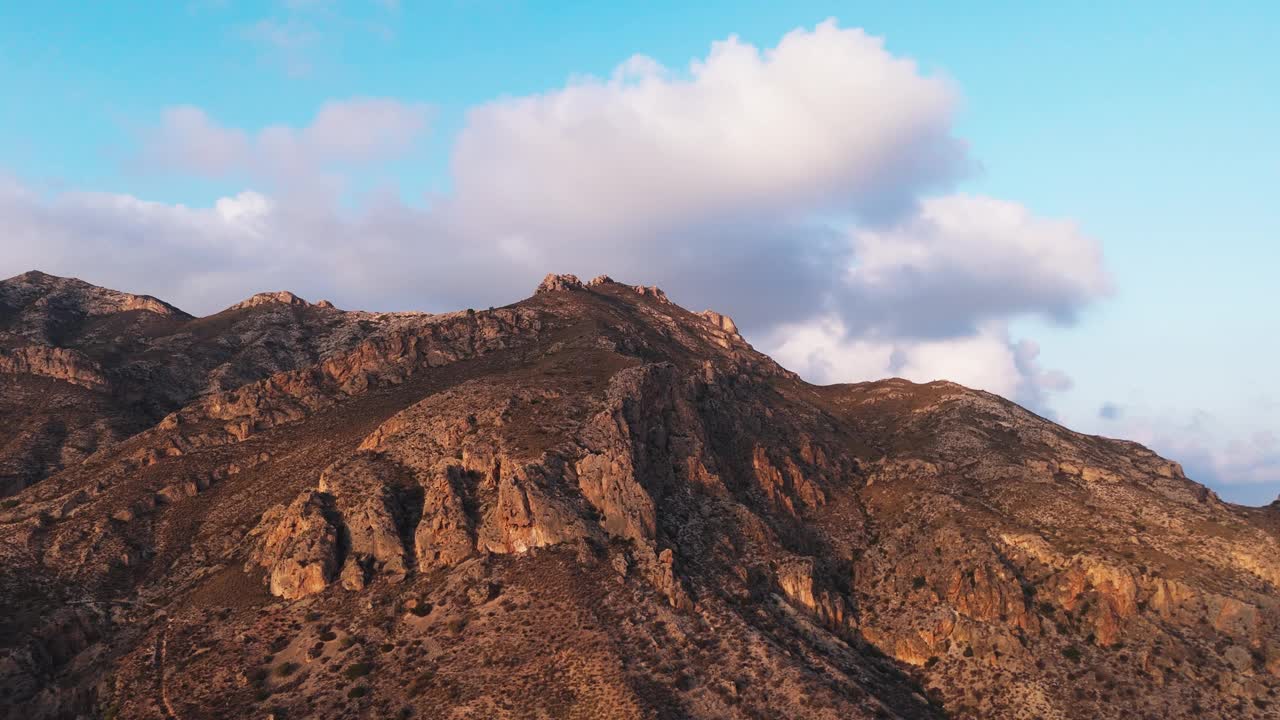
[0,273,1280,720]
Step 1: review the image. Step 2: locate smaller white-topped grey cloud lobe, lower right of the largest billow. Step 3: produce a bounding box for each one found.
[844,195,1110,337]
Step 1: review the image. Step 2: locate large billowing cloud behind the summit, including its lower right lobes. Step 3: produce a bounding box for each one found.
[427,20,1110,407]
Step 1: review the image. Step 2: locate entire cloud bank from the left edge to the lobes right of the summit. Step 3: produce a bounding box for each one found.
[4,20,1108,407]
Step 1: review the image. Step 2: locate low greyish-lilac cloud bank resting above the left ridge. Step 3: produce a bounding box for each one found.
[0,181,471,314]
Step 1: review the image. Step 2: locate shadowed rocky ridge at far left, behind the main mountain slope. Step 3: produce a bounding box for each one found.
[0,272,432,497]
